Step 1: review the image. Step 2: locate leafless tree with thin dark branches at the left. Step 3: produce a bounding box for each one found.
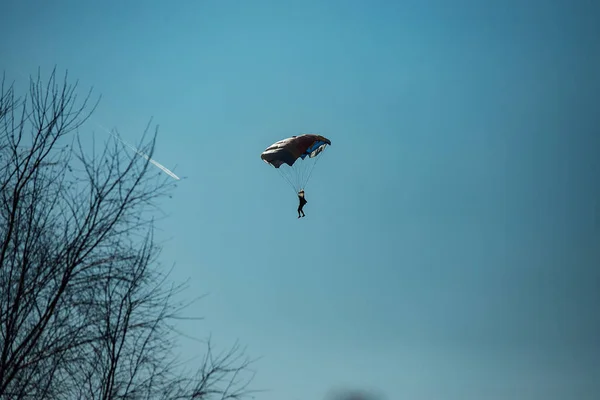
[0,70,252,400]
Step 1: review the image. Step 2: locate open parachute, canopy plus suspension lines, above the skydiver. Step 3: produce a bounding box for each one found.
[260,134,331,193]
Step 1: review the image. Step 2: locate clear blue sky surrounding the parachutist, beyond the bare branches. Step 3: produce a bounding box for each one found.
[0,0,600,400]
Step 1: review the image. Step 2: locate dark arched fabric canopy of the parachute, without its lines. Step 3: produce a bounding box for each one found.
[260,134,331,168]
